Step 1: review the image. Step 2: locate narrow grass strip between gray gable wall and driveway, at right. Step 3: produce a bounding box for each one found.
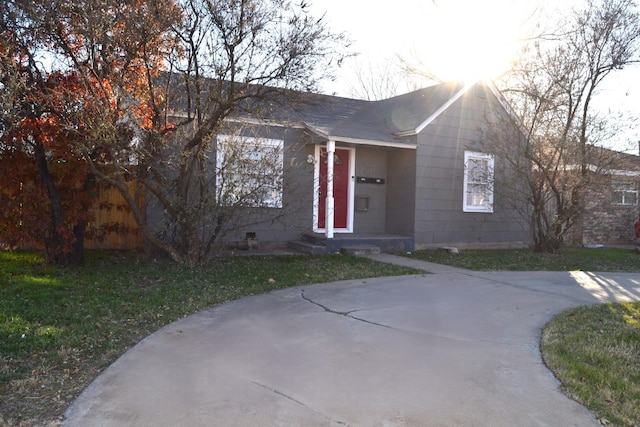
[408,248,640,272]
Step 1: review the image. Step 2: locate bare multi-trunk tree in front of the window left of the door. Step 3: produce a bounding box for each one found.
[142,0,346,264]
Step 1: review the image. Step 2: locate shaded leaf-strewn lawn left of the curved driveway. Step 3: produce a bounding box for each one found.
[0,252,417,426]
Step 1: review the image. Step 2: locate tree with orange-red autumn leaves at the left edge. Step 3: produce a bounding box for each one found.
[0,0,180,256]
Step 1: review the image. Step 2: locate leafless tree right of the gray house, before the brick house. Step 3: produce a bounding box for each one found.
[484,0,640,252]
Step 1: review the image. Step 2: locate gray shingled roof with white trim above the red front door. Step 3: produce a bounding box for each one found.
[161,75,500,148]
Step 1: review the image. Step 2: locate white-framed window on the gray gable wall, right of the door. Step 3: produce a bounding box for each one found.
[462,151,494,213]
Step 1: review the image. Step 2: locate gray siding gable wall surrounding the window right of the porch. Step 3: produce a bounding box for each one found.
[415,91,528,249]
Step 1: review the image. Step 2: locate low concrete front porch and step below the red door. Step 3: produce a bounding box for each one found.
[288,233,414,254]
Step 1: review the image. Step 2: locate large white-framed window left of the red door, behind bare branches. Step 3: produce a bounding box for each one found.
[216,135,284,208]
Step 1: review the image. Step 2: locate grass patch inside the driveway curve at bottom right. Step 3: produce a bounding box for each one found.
[541,303,640,426]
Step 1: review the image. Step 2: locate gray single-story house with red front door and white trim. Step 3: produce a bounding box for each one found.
[175,83,529,252]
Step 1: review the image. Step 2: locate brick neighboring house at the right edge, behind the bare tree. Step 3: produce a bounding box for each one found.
[575,148,640,245]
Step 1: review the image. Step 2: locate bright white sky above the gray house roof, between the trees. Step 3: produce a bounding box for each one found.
[313,0,640,153]
